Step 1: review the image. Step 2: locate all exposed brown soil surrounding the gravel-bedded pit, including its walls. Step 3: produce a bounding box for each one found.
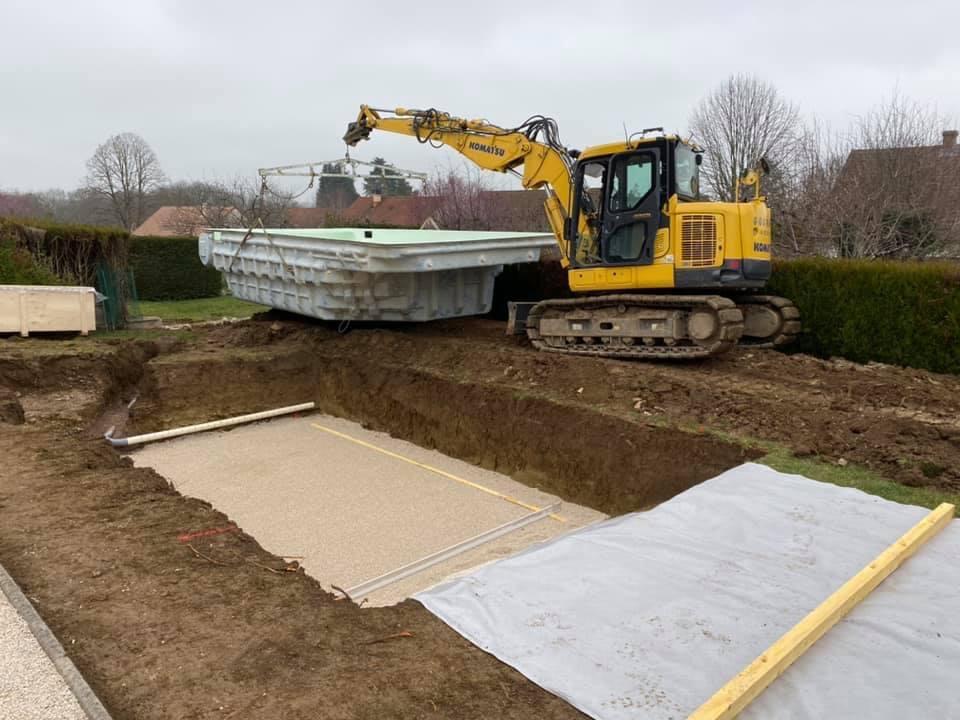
[0,314,960,720]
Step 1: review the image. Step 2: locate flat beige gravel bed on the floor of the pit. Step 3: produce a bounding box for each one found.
[132,415,606,606]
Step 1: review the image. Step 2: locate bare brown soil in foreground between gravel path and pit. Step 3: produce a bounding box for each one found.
[0,426,577,720]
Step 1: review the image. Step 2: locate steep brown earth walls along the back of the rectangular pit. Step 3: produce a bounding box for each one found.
[135,346,749,514]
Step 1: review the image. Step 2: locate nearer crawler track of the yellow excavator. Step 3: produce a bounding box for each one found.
[526,294,743,360]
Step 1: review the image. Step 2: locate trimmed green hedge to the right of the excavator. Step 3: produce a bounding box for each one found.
[769,258,960,373]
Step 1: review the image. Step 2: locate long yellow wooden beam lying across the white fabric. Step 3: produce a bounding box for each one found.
[690,503,954,720]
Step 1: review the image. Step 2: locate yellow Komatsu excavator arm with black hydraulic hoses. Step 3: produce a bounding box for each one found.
[343,105,592,267]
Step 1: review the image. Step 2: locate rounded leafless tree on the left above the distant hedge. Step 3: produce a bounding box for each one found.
[86,133,164,230]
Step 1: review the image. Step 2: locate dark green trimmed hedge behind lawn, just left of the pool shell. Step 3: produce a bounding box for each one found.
[130,237,223,300]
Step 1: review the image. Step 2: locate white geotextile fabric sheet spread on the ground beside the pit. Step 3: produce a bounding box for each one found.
[416,463,960,720]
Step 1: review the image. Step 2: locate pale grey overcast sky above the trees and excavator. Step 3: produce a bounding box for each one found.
[0,0,960,190]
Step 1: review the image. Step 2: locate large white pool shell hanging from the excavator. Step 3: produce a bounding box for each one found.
[199,228,555,322]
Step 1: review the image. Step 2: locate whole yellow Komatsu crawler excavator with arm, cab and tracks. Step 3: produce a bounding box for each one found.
[343,105,800,359]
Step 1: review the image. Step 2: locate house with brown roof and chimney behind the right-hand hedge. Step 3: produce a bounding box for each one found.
[835,130,960,255]
